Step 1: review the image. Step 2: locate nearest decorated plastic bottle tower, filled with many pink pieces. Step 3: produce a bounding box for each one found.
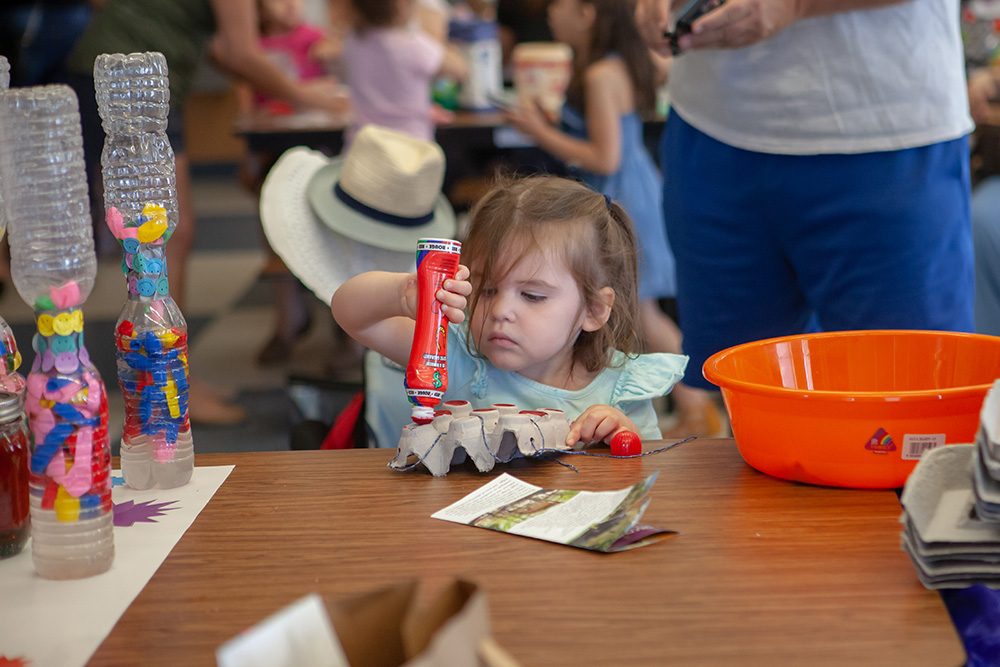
[3,86,114,579]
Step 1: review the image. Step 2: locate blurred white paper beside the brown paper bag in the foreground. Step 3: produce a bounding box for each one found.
[215,593,349,667]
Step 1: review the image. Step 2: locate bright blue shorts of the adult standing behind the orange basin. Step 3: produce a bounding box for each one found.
[661,113,973,388]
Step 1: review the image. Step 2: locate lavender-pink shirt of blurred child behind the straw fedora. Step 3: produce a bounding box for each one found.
[344,28,444,145]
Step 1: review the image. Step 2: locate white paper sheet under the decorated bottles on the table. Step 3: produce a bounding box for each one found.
[0,466,234,667]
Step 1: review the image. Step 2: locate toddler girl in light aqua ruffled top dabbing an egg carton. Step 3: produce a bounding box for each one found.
[331,176,687,446]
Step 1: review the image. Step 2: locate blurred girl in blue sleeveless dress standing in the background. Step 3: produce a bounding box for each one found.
[508,0,721,437]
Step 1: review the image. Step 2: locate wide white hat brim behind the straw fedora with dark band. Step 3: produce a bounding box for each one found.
[260,147,416,303]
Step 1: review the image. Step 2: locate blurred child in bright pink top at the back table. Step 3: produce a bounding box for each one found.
[240,0,346,366]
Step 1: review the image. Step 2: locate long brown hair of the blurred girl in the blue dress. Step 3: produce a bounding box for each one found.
[566,0,656,112]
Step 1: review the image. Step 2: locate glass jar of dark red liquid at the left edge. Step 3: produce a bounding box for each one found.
[0,393,31,558]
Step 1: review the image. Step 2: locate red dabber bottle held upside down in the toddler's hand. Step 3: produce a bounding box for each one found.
[403,239,462,424]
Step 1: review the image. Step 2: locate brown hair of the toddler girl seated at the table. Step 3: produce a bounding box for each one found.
[462,176,641,372]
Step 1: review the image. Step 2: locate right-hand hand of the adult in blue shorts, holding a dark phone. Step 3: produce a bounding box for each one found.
[678,0,802,51]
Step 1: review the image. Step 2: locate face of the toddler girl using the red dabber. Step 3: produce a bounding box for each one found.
[471,251,607,388]
